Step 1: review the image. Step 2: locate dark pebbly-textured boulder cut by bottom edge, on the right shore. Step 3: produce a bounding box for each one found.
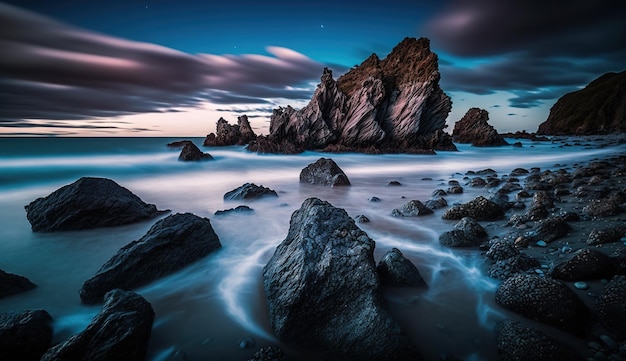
[496,320,582,361]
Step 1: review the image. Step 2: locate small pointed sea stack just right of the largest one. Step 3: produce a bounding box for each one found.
[452,108,509,147]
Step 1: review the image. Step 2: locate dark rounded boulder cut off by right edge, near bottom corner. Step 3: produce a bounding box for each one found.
[595,275,626,338]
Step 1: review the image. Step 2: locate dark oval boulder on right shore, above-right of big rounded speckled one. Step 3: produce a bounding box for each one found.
[550,248,615,281]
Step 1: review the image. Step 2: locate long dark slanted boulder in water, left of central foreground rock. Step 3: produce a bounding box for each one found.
[80,213,222,304]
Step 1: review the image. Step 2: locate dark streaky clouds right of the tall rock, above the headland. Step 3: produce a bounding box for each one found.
[424,0,626,108]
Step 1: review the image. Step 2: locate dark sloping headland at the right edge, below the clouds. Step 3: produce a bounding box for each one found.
[537,71,626,135]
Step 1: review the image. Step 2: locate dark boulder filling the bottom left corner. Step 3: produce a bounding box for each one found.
[0,310,52,361]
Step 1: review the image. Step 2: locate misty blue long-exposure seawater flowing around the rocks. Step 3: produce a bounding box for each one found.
[0,138,626,361]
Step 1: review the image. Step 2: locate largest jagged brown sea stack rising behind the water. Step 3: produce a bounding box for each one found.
[249,38,456,153]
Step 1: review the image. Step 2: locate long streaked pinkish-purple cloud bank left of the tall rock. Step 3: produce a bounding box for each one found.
[0,3,323,124]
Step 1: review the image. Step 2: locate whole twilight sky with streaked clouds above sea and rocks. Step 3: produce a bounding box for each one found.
[0,0,626,137]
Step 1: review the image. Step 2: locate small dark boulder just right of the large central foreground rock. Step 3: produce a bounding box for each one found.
[376,248,426,287]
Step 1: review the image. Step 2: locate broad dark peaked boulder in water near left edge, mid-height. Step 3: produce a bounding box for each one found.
[24,177,161,232]
